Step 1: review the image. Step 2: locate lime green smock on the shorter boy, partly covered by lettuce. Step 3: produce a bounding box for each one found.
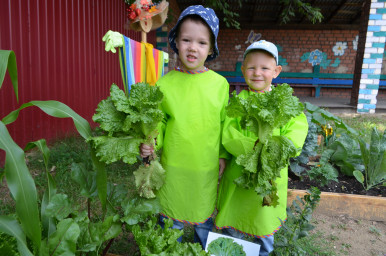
[216,90,308,238]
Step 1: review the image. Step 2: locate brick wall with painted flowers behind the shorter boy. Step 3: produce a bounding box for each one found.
[214,29,358,74]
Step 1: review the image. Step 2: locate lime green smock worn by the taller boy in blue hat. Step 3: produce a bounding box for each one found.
[157,70,229,224]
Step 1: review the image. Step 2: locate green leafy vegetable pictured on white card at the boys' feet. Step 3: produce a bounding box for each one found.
[208,237,246,256]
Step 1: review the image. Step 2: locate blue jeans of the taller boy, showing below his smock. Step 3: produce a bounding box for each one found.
[159,215,213,250]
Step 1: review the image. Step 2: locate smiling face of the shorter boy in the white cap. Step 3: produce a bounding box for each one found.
[241,51,281,91]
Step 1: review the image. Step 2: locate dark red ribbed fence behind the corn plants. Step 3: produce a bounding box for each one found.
[0,0,156,154]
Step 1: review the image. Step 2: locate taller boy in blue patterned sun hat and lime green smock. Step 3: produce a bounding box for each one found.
[141,5,229,248]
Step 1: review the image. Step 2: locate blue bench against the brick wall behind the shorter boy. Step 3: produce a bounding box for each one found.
[217,62,386,98]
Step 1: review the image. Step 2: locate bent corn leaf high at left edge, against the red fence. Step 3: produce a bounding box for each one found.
[0,50,19,101]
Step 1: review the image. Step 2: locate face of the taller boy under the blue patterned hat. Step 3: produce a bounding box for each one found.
[176,19,212,71]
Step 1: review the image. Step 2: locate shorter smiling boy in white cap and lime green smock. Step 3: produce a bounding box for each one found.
[216,40,308,256]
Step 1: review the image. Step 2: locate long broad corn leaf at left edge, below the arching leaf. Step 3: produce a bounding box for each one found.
[0,122,41,248]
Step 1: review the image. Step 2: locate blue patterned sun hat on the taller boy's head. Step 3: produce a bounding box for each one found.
[169,5,219,61]
